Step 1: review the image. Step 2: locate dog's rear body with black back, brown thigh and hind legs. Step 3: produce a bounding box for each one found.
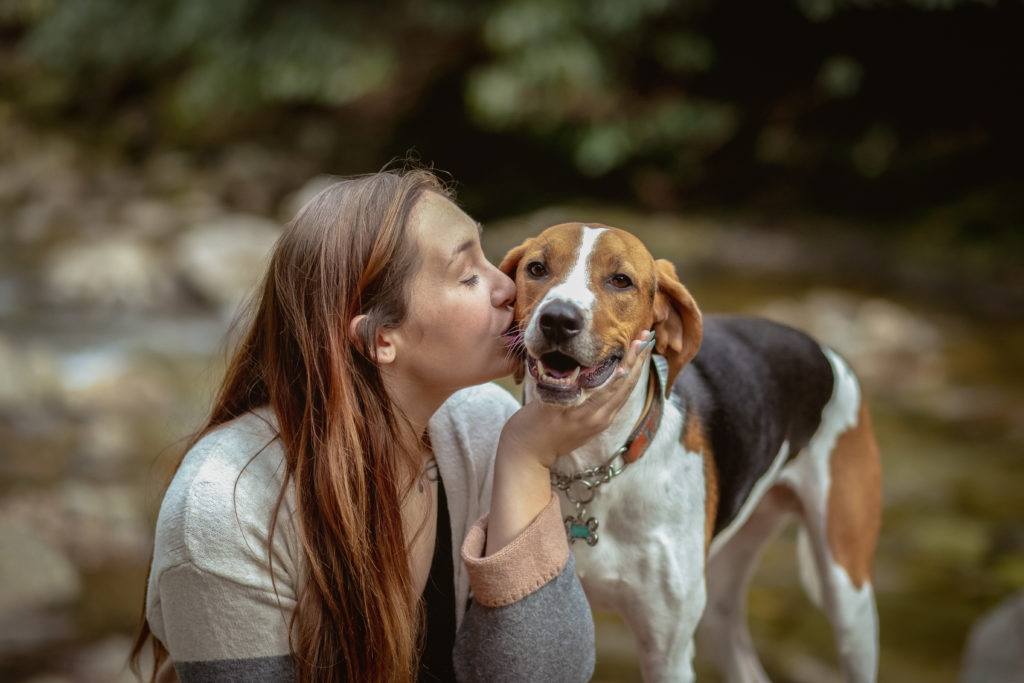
[673,315,881,682]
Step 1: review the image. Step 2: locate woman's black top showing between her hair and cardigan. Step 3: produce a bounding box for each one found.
[417,470,455,683]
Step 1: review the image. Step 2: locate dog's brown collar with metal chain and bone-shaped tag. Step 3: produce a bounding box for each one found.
[551,355,669,546]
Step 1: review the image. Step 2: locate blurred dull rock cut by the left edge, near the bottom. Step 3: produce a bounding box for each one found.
[0,515,81,653]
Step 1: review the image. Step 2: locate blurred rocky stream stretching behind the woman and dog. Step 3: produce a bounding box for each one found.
[0,179,1024,682]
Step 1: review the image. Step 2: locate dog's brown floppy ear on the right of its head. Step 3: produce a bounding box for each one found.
[654,259,703,397]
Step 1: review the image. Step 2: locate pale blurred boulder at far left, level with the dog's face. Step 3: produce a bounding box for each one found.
[43,237,175,311]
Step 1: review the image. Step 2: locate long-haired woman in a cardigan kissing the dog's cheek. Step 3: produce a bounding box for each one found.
[132,170,647,681]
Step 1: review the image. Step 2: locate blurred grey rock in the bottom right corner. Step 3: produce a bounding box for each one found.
[959,591,1024,683]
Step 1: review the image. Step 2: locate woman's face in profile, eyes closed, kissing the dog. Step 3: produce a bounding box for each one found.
[394,191,517,393]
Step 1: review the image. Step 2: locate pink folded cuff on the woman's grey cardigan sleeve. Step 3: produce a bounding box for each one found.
[462,494,569,607]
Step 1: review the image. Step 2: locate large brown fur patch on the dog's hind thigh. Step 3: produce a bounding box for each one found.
[826,401,882,588]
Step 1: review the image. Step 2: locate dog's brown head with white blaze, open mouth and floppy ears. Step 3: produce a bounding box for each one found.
[499,223,701,405]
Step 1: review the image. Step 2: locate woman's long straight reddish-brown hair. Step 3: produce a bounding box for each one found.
[131,169,449,681]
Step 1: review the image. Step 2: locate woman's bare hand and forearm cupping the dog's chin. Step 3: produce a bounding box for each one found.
[485,331,654,555]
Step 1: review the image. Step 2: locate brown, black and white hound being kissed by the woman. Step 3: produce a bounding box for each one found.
[500,223,881,681]
